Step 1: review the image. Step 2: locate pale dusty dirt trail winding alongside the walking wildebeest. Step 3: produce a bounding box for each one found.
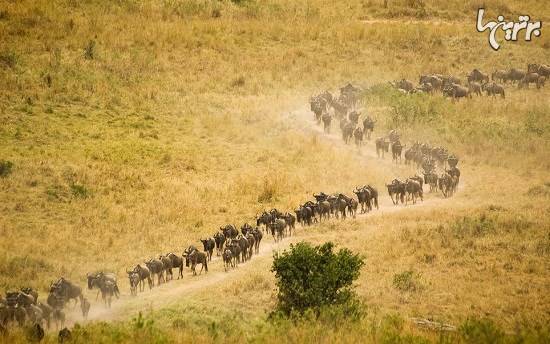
[63,104,464,325]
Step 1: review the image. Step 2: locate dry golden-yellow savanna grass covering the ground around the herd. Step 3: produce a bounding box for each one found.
[0,0,550,342]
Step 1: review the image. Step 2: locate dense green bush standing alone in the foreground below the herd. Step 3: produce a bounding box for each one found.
[272,242,364,316]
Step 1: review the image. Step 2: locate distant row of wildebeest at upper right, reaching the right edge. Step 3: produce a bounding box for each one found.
[390,64,550,99]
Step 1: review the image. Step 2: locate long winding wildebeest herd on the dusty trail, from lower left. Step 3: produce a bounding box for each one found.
[0,79,470,340]
